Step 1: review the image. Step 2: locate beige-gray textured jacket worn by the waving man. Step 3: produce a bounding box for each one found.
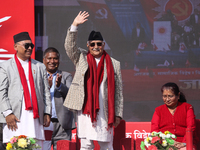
[64,30,123,120]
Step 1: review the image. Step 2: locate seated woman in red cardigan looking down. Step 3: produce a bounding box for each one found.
[151,83,197,150]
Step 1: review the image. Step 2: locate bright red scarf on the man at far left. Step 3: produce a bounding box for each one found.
[15,54,39,118]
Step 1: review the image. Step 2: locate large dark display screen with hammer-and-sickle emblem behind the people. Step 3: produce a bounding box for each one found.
[35,0,200,122]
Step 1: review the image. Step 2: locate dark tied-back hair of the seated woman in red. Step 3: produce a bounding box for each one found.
[161,82,187,102]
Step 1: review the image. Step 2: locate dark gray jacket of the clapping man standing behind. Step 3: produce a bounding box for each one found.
[54,70,76,130]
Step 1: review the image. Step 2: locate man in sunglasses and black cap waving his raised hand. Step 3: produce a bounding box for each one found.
[64,11,123,150]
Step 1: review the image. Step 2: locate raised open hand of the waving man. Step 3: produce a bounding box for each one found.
[72,11,89,26]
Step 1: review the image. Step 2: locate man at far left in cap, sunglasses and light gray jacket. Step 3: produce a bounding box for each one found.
[0,32,51,149]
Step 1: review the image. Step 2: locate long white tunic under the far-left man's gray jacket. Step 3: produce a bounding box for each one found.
[3,58,45,143]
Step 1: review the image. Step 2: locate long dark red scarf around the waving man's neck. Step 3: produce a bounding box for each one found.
[83,51,115,127]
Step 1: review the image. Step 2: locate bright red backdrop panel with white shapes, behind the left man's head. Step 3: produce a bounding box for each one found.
[0,0,35,62]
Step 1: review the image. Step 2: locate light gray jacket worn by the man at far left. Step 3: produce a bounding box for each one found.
[0,58,51,124]
